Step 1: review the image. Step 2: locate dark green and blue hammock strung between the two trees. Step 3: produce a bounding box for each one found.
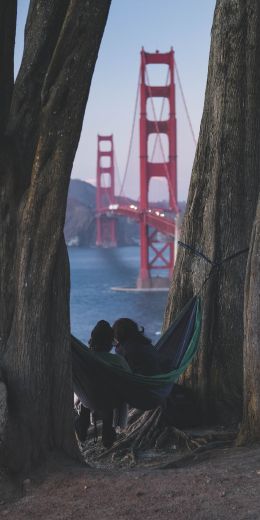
[71,296,201,410]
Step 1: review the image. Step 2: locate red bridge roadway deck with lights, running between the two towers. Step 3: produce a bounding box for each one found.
[97,204,176,237]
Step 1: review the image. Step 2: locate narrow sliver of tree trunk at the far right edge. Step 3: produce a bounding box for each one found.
[238,196,260,443]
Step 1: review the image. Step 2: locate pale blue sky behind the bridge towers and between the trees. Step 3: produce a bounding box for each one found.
[15,0,215,200]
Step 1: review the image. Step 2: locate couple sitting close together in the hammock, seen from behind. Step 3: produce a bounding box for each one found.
[76,318,160,448]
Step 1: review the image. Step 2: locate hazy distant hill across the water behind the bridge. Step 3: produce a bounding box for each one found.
[64,179,186,247]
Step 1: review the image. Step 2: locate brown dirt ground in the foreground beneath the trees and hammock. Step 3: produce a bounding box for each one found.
[0,447,260,520]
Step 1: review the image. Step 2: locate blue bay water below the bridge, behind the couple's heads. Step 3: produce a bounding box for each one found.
[69,247,167,343]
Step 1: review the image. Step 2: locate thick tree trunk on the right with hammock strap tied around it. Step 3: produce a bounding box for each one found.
[164,0,260,424]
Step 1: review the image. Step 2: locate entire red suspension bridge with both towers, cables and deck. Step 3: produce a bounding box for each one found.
[96,49,195,289]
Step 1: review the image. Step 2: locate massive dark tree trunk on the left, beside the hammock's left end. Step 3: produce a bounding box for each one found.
[0,0,110,471]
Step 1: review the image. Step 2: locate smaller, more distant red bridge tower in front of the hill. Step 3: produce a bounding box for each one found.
[96,135,117,247]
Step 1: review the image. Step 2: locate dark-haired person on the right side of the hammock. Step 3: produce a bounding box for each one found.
[112,318,161,376]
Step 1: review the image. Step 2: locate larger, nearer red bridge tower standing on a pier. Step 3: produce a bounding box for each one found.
[138,49,178,288]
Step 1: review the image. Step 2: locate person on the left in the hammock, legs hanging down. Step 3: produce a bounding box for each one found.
[76,320,131,448]
